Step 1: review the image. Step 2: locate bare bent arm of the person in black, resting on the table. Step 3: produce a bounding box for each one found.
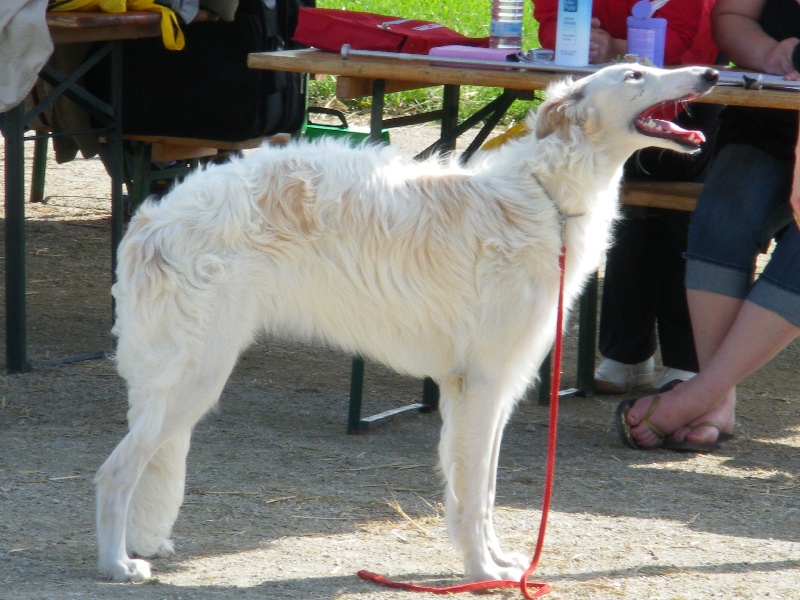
[711,0,800,81]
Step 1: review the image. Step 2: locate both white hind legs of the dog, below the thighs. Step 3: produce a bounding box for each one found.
[95,350,237,581]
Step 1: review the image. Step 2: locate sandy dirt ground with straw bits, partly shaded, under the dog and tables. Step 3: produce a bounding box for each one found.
[0,123,800,600]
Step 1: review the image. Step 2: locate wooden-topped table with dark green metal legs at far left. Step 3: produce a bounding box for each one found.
[2,11,202,373]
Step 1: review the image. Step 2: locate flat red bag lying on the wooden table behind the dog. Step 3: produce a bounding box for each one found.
[292,8,489,54]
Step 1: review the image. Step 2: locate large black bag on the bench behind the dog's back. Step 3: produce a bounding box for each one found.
[87,0,315,142]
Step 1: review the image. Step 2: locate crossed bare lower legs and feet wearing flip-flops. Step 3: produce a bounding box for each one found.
[628,292,800,447]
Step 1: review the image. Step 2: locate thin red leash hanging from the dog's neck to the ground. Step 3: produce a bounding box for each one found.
[358,249,566,600]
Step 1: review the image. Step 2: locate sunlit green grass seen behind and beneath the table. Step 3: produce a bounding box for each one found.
[309,0,539,124]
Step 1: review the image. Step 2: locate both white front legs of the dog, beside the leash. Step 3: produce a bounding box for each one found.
[439,376,527,581]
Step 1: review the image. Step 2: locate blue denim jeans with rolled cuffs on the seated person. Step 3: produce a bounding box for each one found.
[685,144,800,326]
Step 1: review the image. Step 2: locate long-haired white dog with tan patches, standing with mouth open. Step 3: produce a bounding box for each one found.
[96,64,717,581]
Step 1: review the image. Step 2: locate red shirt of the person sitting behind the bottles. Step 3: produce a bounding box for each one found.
[533,0,719,65]
